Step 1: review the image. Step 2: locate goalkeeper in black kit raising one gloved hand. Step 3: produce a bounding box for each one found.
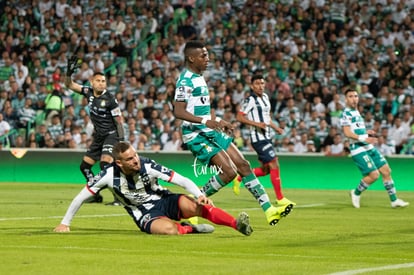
[65,56,124,205]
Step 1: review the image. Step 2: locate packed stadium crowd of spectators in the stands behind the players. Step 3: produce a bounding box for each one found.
[0,0,414,156]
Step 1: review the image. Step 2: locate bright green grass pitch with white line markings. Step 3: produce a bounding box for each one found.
[0,183,414,275]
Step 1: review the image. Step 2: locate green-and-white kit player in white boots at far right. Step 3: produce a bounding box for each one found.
[341,89,409,208]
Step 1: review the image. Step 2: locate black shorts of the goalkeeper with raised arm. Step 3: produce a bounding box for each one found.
[86,133,119,161]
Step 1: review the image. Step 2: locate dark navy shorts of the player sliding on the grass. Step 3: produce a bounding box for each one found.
[133,194,182,234]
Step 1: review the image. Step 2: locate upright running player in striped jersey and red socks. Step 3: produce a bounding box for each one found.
[234,74,295,208]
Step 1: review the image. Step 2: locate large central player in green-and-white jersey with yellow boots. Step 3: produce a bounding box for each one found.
[174,41,293,225]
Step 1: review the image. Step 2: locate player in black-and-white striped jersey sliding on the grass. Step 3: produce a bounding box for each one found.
[54,142,253,236]
